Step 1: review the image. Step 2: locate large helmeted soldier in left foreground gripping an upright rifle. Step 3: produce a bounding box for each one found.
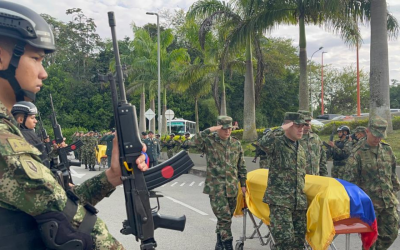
[0,1,147,250]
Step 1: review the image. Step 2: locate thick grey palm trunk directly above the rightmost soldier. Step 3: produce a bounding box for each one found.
[369,0,393,132]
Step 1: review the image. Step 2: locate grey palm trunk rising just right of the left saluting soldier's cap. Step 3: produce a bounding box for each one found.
[243,36,257,141]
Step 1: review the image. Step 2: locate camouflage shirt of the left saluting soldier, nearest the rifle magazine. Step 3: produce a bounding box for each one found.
[190,129,247,197]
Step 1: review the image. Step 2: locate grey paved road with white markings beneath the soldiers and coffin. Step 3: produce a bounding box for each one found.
[72,164,400,250]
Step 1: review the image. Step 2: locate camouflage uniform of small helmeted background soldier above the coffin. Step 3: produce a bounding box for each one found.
[327,139,352,179]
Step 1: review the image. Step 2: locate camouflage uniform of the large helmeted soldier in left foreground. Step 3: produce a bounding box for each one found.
[0,102,124,249]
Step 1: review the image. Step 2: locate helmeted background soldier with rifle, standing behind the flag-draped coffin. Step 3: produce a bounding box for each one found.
[327,125,352,179]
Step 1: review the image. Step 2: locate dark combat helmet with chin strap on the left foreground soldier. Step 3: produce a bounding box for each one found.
[0,1,56,102]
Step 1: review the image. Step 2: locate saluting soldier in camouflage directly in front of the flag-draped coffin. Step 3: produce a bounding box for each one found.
[260,112,307,250]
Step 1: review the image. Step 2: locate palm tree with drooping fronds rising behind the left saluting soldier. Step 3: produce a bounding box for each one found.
[188,0,266,141]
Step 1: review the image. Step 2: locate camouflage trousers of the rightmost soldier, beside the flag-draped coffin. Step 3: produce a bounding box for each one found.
[370,206,399,250]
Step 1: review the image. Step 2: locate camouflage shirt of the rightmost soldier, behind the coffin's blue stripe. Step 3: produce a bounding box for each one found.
[344,140,400,208]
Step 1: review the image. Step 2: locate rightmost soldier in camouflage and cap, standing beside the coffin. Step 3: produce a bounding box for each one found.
[344,116,400,250]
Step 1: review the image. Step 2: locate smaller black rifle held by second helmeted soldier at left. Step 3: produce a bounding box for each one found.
[50,94,83,190]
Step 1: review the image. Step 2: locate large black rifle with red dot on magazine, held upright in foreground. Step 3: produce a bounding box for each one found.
[99,12,193,250]
